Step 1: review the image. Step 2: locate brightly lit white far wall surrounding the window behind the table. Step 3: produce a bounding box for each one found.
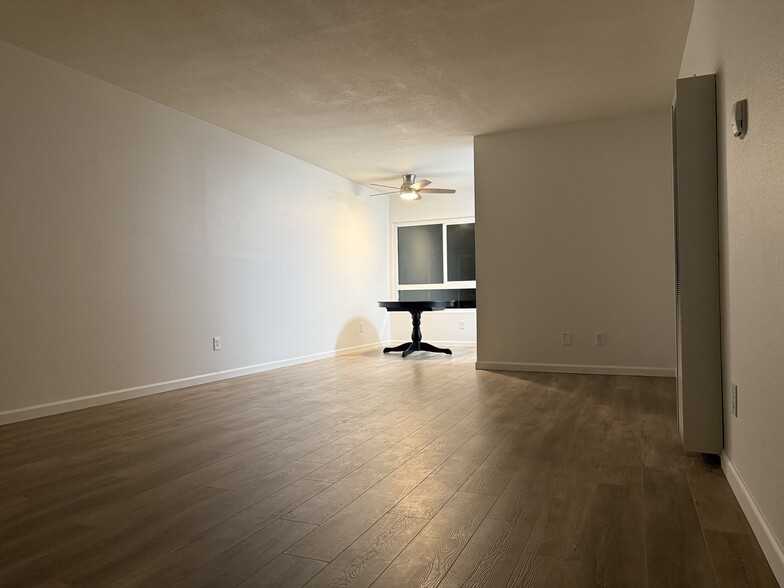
[389,181,476,346]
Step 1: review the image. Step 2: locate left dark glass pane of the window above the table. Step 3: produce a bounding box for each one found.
[397,225,444,284]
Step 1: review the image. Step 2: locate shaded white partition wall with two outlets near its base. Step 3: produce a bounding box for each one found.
[474,110,675,375]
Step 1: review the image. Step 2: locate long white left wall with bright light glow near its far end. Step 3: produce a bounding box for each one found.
[0,44,389,422]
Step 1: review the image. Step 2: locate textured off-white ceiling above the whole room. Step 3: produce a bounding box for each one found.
[0,0,692,187]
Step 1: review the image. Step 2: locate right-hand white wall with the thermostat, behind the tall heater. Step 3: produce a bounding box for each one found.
[680,0,784,585]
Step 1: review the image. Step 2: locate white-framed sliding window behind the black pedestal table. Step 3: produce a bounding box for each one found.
[396,219,476,308]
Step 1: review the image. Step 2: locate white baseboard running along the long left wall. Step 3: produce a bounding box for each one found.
[0,341,384,425]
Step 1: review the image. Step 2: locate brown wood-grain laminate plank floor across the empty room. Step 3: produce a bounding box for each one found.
[0,350,776,588]
